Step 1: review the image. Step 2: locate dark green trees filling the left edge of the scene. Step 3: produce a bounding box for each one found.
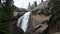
[0,0,13,34]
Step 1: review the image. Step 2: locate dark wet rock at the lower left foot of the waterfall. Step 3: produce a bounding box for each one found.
[11,18,24,34]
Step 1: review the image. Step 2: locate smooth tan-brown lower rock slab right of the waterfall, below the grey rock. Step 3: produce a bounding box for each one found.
[26,14,51,34]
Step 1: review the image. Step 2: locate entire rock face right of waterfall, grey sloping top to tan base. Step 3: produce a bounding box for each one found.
[26,1,52,34]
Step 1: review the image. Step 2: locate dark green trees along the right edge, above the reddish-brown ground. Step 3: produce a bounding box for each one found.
[51,0,60,29]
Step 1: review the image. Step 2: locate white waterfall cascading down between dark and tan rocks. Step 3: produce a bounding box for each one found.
[17,12,30,32]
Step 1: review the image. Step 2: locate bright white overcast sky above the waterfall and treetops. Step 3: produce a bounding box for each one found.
[14,0,45,9]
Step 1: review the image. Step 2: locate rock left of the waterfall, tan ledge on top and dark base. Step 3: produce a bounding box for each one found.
[11,6,28,34]
